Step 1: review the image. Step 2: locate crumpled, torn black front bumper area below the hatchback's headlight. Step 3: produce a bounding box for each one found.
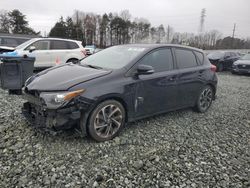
[22,93,90,130]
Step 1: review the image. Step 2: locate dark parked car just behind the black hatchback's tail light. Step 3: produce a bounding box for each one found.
[207,51,240,72]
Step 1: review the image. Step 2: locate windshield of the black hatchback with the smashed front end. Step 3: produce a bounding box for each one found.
[81,46,145,69]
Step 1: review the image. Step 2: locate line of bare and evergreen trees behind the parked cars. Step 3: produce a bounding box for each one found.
[0,10,250,49]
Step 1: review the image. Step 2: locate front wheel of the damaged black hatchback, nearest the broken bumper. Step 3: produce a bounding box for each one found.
[87,100,126,142]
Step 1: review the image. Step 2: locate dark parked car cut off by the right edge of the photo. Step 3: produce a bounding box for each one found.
[231,54,250,74]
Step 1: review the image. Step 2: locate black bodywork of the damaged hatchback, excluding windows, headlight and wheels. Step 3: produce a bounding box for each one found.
[24,45,217,135]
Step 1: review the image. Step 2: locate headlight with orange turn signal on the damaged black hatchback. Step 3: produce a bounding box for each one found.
[40,89,85,109]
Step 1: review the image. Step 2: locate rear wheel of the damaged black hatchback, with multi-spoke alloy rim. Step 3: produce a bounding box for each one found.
[195,85,214,113]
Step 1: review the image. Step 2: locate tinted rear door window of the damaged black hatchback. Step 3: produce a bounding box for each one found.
[175,49,197,68]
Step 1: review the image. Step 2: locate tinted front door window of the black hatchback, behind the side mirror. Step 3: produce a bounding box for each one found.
[140,49,173,72]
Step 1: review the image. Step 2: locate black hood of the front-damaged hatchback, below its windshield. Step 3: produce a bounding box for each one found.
[25,64,112,91]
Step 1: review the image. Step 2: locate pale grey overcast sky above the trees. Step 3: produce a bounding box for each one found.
[0,0,250,38]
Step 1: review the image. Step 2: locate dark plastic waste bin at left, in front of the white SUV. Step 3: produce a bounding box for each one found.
[0,56,35,94]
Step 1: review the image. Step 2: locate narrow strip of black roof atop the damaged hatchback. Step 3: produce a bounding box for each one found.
[118,44,203,52]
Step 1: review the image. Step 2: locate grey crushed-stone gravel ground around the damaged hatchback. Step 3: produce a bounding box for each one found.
[0,73,250,188]
